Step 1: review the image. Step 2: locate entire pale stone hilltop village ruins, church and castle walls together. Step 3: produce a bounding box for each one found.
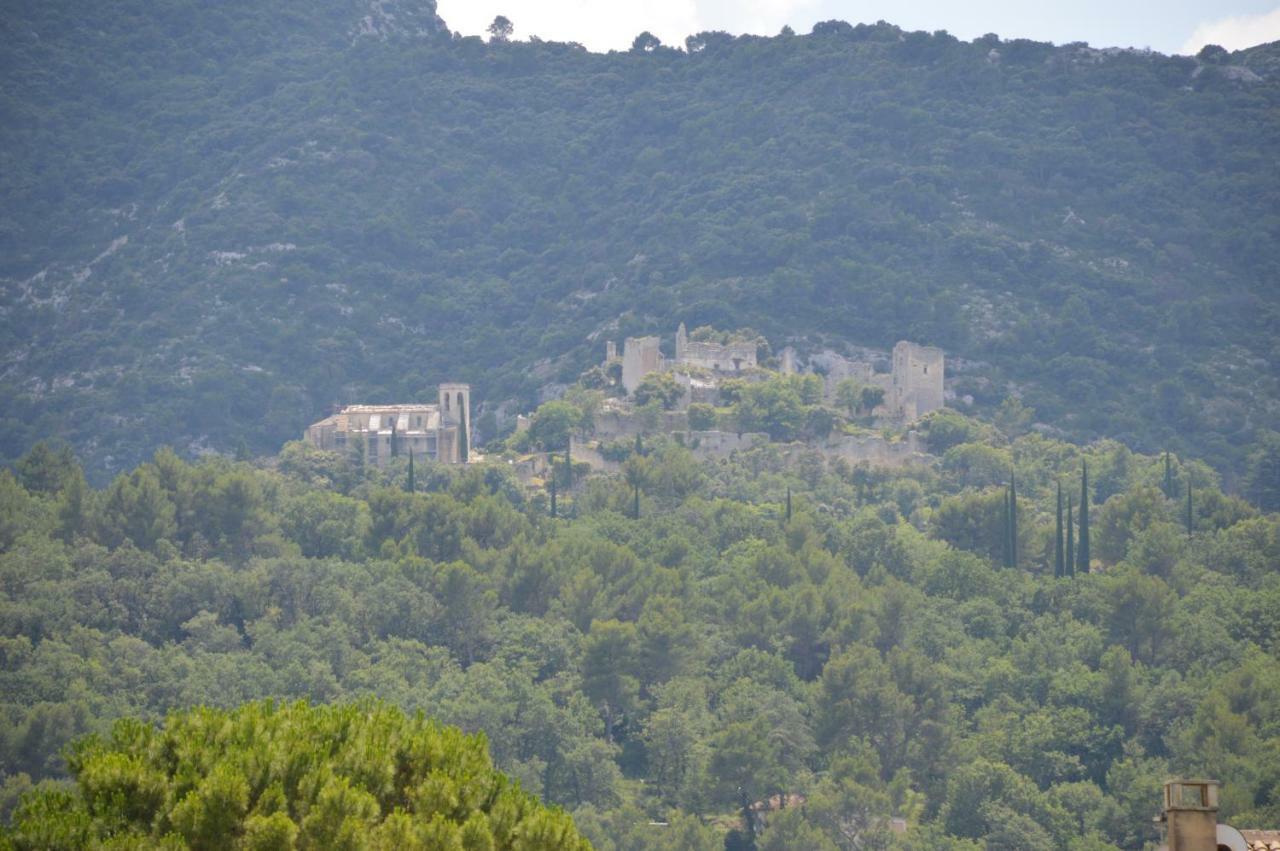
[305,322,945,477]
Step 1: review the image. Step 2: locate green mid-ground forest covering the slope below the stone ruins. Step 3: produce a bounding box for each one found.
[0,411,1280,851]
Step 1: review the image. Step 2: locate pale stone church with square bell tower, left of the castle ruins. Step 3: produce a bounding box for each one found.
[303,383,471,467]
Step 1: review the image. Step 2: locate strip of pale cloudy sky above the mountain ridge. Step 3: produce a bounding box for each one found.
[439,0,1280,54]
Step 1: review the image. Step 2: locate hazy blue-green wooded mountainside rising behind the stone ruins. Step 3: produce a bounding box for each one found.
[0,0,1280,484]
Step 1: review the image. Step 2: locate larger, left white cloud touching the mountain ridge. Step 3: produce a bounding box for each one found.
[439,0,818,51]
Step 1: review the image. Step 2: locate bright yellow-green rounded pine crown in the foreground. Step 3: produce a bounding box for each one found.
[0,701,590,851]
